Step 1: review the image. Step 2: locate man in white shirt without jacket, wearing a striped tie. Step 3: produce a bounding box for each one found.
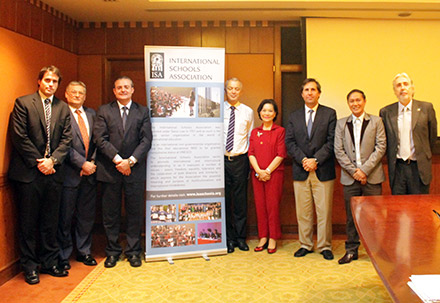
[224,78,254,253]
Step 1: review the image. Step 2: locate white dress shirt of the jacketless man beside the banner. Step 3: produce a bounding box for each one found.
[223,101,254,156]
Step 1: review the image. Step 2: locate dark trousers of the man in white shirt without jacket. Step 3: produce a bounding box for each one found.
[225,154,249,241]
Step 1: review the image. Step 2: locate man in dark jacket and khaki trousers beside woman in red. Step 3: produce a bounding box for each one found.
[286,78,336,260]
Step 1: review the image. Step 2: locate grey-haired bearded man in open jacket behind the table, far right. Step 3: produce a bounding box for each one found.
[380,73,437,195]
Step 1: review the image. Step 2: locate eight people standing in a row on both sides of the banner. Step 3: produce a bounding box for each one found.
[9,66,437,284]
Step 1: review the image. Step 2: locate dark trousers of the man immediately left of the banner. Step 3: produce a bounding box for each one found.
[102,179,145,257]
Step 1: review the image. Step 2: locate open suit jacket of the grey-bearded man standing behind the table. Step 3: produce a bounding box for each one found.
[380,99,437,186]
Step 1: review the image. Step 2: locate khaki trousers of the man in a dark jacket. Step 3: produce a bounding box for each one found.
[293,172,335,252]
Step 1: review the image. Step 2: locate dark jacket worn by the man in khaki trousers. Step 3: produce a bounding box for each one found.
[286,104,336,181]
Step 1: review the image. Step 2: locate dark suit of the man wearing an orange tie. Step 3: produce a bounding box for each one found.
[57,107,96,260]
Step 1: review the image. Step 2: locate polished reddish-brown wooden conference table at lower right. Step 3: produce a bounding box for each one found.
[351,195,440,302]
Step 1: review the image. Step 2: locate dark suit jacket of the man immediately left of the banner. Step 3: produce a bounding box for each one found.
[93,101,153,183]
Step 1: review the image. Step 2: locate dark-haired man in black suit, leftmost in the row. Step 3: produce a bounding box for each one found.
[9,66,72,284]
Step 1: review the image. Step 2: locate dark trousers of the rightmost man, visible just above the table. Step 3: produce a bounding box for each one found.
[391,159,430,195]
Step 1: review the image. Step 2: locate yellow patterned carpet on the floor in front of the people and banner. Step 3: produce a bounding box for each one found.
[63,240,392,303]
